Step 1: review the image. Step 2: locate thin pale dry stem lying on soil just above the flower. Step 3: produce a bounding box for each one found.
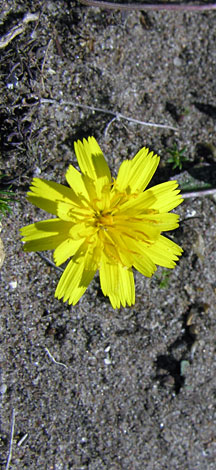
[40,98,179,132]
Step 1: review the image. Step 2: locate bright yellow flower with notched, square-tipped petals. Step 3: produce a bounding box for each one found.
[21,137,183,308]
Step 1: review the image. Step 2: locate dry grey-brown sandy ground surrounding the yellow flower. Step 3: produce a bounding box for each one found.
[0,0,216,470]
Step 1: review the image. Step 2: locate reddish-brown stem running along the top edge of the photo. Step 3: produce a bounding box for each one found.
[80,0,216,11]
